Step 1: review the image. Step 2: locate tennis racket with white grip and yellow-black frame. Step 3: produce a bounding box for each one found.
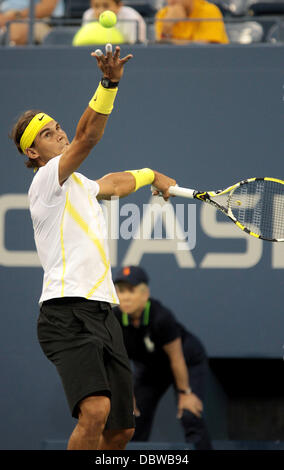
[152,177,284,242]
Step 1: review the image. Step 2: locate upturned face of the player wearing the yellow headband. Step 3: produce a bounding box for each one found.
[31,120,69,163]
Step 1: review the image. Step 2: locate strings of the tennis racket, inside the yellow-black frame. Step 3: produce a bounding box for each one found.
[228,180,284,239]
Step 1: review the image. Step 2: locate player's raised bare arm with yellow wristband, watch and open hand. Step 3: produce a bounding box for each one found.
[59,44,132,184]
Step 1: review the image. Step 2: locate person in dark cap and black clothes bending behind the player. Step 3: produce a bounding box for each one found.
[114,266,212,450]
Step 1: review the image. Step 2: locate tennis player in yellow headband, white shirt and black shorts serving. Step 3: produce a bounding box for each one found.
[11,45,175,450]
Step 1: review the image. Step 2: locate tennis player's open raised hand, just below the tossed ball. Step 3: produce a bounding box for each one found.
[91,44,133,82]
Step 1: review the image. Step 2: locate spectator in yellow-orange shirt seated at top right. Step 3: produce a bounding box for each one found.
[155,0,229,44]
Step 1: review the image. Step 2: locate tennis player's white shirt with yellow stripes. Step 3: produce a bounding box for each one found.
[29,155,119,304]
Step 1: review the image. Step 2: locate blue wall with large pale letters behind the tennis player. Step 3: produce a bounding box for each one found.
[0,45,284,449]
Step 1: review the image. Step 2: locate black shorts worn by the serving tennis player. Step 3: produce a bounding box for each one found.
[38,297,134,429]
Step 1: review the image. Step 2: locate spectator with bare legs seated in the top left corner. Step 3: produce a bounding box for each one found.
[0,0,64,46]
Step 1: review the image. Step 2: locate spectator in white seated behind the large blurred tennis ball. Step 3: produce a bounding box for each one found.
[82,0,146,44]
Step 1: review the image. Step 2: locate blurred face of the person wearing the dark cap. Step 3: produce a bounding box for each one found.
[115,282,149,314]
